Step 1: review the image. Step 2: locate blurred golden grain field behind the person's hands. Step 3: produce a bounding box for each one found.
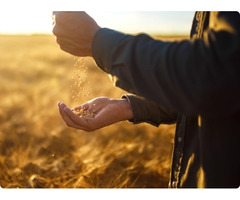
[0,35,181,188]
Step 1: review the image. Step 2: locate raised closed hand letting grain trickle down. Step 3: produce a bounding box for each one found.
[53,11,100,56]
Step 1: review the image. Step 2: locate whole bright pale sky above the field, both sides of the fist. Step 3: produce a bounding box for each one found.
[0,9,194,35]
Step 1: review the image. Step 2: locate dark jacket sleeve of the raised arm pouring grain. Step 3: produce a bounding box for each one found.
[93,12,240,117]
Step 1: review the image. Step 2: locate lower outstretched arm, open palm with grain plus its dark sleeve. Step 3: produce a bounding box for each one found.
[58,95,177,132]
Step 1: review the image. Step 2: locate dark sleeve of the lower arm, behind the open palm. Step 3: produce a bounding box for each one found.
[122,94,177,126]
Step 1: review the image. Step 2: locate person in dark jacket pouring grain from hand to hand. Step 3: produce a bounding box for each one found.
[53,11,240,188]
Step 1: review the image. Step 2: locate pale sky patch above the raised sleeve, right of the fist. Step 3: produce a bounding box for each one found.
[89,11,194,35]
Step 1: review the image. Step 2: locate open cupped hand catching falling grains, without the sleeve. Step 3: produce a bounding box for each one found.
[58,97,133,132]
